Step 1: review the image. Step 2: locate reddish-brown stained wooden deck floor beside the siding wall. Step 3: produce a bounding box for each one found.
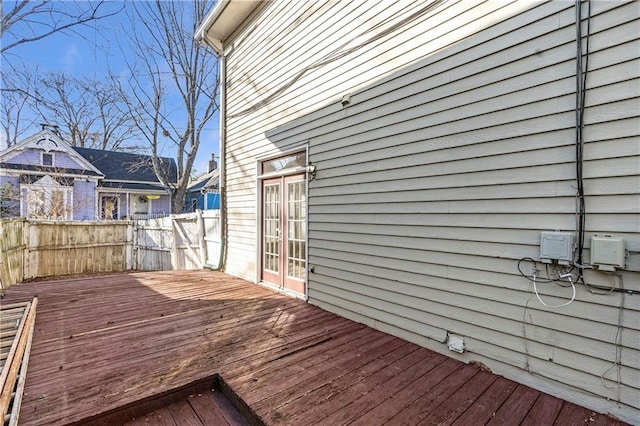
[2,271,632,425]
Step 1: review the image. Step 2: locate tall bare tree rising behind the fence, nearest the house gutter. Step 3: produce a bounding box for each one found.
[119,0,219,212]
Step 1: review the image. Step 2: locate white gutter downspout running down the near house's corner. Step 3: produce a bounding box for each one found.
[201,53,227,271]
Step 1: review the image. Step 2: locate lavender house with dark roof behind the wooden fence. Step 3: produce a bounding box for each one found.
[0,129,177,220]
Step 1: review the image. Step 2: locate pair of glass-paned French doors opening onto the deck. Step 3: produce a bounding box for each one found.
[261,174,307,294]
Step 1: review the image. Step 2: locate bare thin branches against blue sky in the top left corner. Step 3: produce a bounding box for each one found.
[0,0,122,54]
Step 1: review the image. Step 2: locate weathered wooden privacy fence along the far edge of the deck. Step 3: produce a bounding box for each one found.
[0,210,220,289]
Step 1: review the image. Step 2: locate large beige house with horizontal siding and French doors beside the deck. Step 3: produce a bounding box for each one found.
[196,0,640,423]
